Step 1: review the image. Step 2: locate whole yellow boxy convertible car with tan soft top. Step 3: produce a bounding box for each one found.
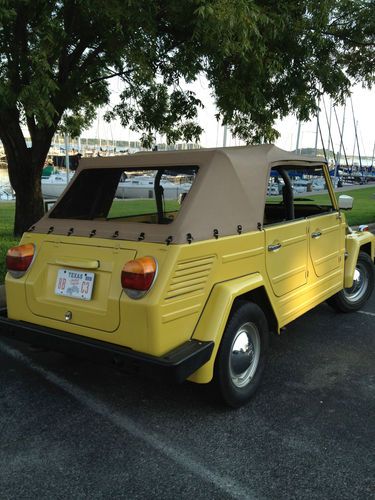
[0,145,375,407]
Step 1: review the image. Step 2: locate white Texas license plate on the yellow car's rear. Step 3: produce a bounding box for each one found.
[55,269,95,300]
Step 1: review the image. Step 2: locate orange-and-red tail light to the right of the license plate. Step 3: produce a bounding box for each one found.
[121,257,158,299]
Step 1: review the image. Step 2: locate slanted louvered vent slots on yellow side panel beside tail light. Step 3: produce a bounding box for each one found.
[165,255,215,301]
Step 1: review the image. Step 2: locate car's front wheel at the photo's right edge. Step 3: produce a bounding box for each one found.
[327,252,375,312]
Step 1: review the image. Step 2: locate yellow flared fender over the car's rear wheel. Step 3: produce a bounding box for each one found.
[188,273,271,384]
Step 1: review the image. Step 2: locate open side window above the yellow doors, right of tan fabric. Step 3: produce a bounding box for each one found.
[264,166,334,225]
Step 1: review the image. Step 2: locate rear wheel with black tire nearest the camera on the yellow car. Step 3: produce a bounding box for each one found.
[214,301,269,408]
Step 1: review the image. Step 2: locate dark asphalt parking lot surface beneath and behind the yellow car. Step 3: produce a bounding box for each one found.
[0,294,375,499]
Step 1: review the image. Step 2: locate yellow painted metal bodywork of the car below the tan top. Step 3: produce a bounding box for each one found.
[6,212,375,383]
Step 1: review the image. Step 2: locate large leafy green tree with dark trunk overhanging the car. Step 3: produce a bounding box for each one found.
[0,0,374,234]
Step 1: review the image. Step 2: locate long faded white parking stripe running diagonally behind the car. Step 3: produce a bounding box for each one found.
[0,342,260,499]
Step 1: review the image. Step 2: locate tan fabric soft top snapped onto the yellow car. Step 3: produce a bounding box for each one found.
[34,144,325,244]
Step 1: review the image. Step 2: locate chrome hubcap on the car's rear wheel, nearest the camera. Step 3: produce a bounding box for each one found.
[229,323,260,387]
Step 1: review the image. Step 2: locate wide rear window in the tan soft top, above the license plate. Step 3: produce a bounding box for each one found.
[49,166,198,224]
